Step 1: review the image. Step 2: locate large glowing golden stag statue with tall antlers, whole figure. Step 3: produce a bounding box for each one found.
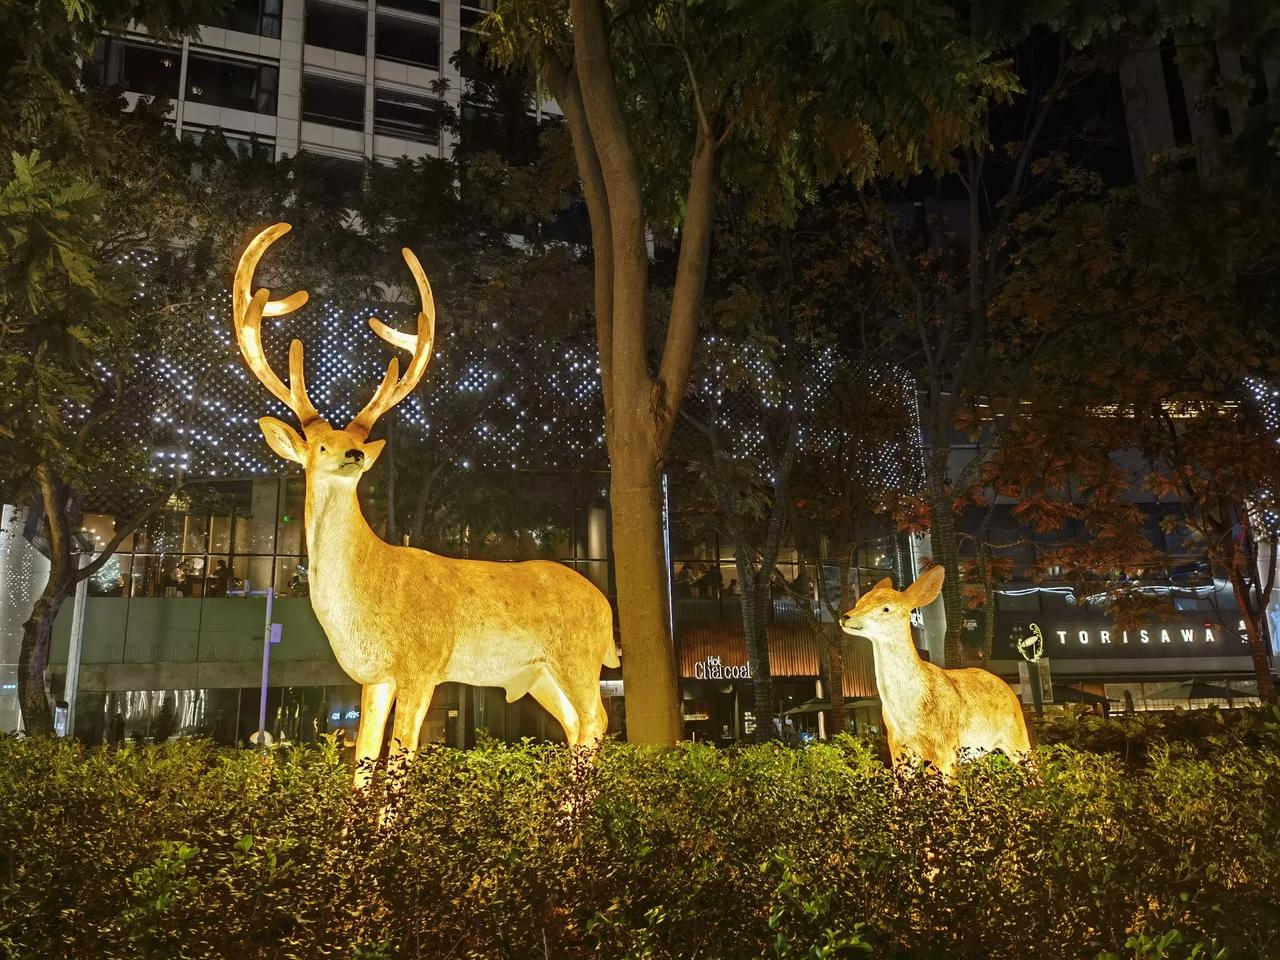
[232,224,618,783]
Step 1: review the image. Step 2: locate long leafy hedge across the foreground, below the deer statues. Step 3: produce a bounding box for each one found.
[0,717,1280,960]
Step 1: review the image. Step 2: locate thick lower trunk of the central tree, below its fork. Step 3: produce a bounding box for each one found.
[609,455,682,744]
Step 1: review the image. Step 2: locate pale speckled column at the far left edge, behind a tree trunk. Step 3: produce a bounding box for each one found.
[0,503,49,733]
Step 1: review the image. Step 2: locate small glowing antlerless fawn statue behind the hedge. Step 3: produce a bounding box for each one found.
[840,567,1030,777]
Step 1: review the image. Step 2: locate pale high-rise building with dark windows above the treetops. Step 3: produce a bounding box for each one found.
[96,0,552,179]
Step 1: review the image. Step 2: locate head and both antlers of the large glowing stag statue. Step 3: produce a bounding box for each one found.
[232,223,435,486]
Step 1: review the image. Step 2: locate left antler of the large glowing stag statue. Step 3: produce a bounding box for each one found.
[232,223,321,431]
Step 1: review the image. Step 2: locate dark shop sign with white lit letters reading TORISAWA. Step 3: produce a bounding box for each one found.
[997,621,1249,659]
